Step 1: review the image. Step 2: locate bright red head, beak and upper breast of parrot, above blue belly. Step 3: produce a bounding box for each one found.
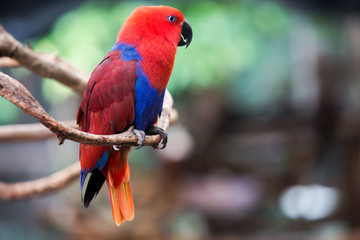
[117,6,192,90]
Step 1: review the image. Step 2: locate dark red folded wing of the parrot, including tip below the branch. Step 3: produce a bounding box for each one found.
[77,50,137,176]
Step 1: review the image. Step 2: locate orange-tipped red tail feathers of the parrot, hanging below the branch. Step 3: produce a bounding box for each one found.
[106,147,134,226]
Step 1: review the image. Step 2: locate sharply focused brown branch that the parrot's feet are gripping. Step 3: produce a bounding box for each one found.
[0,72,173,147]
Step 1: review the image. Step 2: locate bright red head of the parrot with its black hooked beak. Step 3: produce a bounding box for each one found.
[118,6,192,47]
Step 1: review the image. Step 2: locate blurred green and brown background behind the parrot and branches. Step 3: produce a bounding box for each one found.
[0,0,360,239]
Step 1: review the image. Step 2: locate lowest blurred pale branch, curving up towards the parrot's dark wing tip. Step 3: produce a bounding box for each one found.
[0,162,80,201]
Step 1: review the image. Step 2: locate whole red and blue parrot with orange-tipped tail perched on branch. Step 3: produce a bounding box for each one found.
[77,6,192,226]
